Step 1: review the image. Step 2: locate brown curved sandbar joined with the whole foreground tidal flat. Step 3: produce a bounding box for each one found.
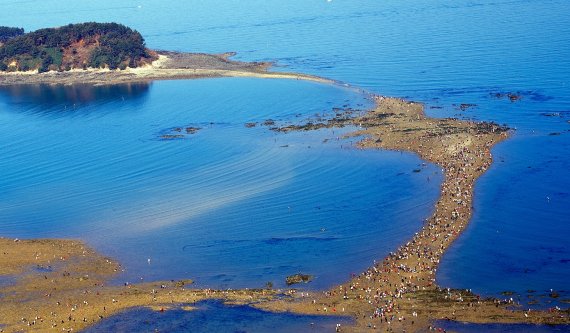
[0,92,570,332]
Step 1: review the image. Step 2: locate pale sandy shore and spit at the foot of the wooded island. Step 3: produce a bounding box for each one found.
[0,51,334,85]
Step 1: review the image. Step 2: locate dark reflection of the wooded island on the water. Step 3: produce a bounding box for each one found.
[0,82,151,116]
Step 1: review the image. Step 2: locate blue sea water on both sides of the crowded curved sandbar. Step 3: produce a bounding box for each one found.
[0,0,570,328]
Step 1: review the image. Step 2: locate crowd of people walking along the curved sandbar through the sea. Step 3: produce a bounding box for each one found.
[304,95,508,331]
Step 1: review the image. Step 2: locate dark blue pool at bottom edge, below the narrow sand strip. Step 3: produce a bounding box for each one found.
[84,300,351,333]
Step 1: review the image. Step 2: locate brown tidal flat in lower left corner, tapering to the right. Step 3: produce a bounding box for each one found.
[0,238,275,332]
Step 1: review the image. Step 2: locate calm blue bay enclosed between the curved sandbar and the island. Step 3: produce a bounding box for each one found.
[0,79,441,288]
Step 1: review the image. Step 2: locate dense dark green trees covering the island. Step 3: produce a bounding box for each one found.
[0,22,156,73]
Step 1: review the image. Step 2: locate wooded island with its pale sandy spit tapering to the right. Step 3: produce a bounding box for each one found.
[0,23,334,85]
